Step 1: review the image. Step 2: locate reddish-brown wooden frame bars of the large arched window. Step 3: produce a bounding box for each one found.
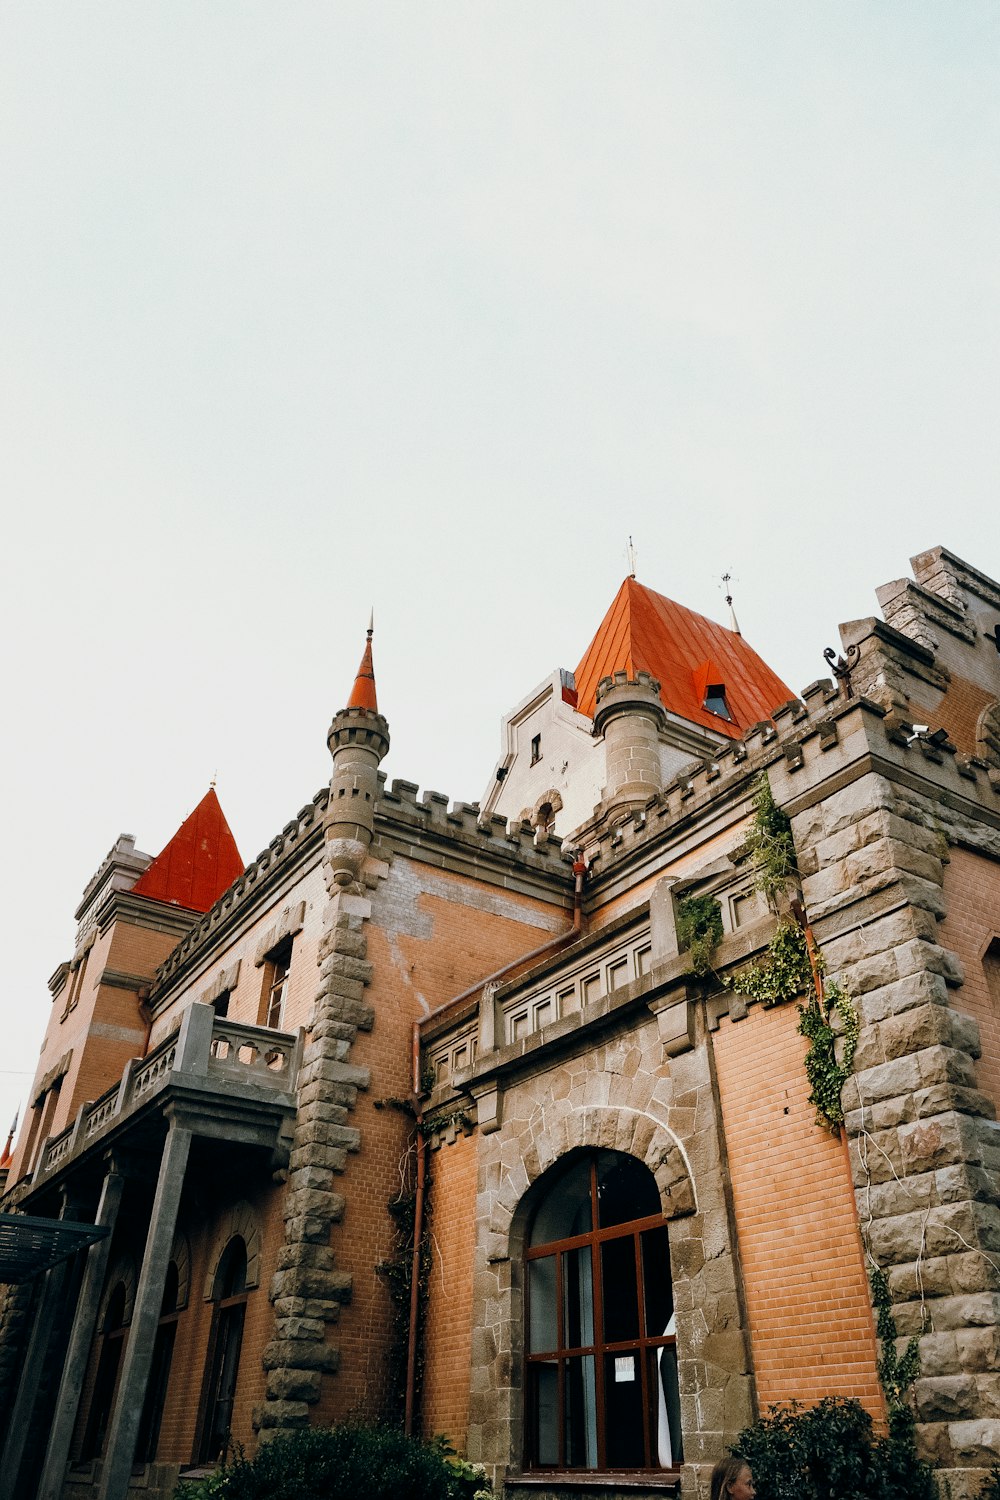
[523,1149,682,1482]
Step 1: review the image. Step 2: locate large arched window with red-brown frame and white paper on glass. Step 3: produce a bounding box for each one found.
[525,1151,682,1470]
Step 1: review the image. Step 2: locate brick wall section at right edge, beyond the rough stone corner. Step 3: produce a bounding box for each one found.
[939,849,1000,1110]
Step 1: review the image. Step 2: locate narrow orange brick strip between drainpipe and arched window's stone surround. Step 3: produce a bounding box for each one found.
[420,1136,477,1452]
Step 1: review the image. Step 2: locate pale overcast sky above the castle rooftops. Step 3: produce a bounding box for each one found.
[0,0,1000,1145]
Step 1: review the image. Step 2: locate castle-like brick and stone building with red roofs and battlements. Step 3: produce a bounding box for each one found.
[0,548,1000,1500]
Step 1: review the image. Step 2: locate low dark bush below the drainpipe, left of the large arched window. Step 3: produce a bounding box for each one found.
[175,1427,490,1500]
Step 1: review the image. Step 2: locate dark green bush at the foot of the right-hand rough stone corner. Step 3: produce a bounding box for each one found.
[733,1397,937,1500]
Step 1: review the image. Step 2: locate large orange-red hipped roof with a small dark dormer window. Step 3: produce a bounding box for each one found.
[576,578,795,738]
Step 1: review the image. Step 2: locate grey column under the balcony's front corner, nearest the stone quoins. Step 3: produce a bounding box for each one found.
[97,1115,192,1500]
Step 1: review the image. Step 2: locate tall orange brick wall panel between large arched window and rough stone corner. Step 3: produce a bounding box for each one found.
[715,1005,885,1416]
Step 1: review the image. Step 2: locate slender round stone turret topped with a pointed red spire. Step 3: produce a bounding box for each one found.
[325,621,388,888]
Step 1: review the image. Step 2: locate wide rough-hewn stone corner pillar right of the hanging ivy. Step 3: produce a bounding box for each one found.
[792,773,1000,1500]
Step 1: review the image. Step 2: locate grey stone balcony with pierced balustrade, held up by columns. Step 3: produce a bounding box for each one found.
[24,1004,303,1196]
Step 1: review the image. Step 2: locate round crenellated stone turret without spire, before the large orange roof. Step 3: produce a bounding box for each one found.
[594,672,667,812]
